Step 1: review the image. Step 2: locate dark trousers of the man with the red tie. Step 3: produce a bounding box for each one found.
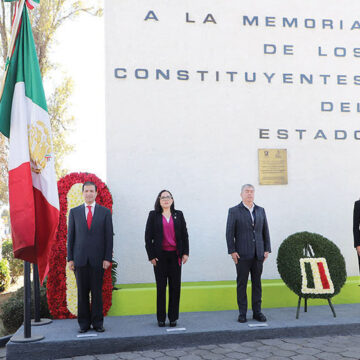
[75,263,104,329]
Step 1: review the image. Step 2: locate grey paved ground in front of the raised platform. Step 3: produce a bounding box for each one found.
[53,335,360,360]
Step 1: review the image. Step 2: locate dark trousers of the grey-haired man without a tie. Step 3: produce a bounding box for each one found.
[236,258,264,315]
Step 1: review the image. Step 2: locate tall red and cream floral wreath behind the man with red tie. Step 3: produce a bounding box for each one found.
[47,173,113,319]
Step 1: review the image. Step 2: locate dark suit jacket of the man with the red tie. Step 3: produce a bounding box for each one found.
[67,204,113,267]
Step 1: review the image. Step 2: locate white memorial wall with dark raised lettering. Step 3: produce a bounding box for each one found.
[105,0,360,283]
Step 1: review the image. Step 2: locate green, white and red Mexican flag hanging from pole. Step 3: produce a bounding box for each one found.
[0,6,59,281]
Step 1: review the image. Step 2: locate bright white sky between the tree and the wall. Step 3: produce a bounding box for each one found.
[49,10,106,181]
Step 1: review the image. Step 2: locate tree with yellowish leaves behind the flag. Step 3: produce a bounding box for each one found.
[0,0,102,204]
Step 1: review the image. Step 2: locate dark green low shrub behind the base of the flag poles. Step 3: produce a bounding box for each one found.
[0,283,51,334]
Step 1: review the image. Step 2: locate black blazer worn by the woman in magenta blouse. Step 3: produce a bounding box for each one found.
[145,210,189,260]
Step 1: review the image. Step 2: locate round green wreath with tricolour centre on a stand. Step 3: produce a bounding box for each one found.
[277,232,346,319]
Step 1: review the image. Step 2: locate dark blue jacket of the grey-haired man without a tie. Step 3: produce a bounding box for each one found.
[226,202,271,260]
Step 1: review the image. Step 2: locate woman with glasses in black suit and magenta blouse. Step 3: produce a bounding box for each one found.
[145,190,189,327]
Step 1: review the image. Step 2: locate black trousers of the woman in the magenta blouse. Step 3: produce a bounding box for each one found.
[154,251,181,321]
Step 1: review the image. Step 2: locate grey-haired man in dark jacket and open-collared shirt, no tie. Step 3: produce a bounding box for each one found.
[226,184,271,323]
